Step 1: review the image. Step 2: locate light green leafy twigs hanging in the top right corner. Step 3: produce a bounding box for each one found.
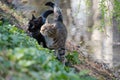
[99,0,120,29]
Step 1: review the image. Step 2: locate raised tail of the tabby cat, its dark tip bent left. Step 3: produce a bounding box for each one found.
[45,2,63,22]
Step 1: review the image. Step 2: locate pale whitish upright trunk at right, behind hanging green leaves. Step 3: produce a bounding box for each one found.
[91,0,113,66]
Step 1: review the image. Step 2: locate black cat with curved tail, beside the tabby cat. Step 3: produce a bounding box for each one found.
[28,10,53,48]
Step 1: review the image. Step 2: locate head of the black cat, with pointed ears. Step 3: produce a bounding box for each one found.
[28,15,43,32]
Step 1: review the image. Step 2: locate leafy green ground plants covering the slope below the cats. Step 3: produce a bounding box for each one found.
[0,21,96,80]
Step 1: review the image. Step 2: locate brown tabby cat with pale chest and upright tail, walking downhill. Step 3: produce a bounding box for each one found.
[40,2,67,63]
